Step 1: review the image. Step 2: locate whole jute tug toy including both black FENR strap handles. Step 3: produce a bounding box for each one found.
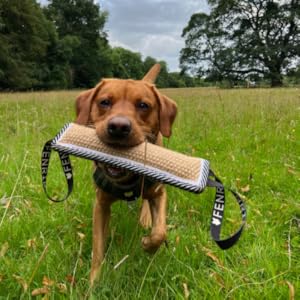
[41,123,246,249]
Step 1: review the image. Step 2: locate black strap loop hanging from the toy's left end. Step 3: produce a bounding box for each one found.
[41,140,73,202]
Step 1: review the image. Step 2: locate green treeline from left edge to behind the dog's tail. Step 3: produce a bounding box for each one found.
[0,0,195,90]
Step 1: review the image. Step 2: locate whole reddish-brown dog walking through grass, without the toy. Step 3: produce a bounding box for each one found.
[76,64,177,284]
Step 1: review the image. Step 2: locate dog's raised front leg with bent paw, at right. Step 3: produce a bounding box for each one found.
[142,185,167,252]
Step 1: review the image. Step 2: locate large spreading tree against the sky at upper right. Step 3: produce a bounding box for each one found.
[180,0,300,86]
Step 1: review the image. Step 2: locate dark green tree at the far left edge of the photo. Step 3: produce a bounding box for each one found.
[0,0,53,89]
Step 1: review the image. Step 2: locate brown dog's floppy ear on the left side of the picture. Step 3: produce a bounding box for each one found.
[75,81,103,125]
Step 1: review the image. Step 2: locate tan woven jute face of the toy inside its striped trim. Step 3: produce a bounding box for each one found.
[58,123,201,181]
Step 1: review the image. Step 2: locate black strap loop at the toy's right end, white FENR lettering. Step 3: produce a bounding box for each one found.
[207,170,246,249]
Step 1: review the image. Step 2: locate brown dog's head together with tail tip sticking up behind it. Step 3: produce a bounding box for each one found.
[76,64,177,147]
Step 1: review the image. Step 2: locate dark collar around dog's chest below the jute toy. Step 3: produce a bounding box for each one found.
[93,167,155,201]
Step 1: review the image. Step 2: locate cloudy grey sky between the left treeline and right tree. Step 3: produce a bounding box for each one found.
[39,0,208,72]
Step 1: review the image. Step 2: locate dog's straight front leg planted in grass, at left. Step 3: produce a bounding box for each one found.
[90,189,113,285]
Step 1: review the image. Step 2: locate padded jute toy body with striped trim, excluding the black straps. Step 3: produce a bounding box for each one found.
[52,123,209,193]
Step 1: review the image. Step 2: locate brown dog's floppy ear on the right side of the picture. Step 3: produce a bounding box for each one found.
[152,87,177,137]
